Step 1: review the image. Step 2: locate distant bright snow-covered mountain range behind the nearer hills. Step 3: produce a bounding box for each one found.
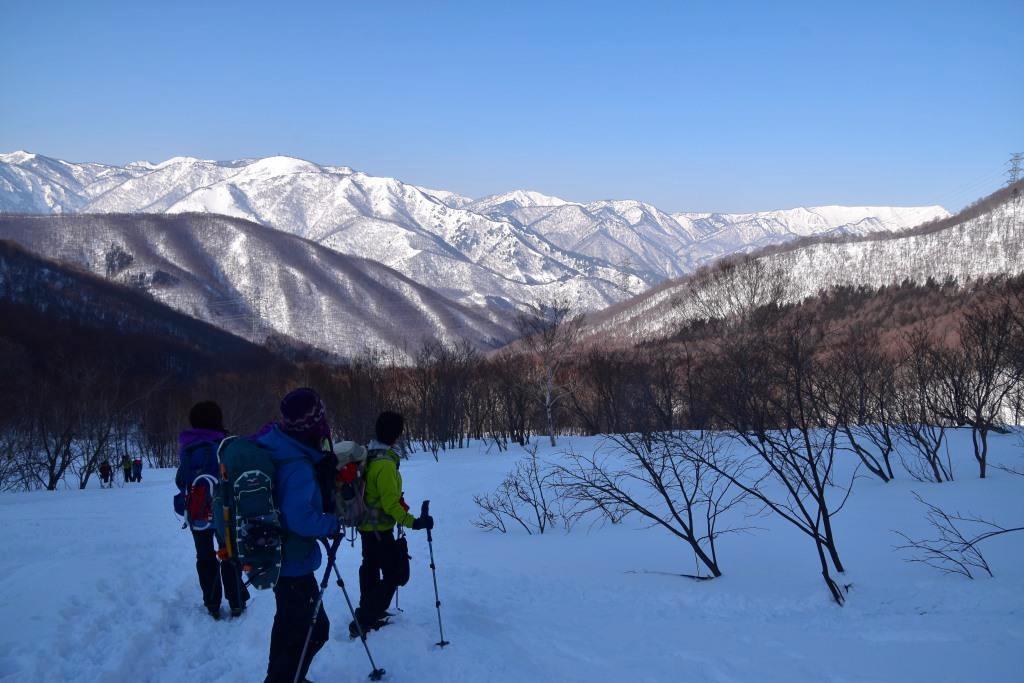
[0,152,948,313]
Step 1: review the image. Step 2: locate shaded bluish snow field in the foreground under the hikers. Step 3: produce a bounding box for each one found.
[0,433,1024,683]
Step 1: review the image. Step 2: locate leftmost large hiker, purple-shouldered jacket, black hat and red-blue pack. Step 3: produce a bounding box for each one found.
[174,400,249,618]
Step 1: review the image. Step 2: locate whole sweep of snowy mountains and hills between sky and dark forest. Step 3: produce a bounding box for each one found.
[0,153,1021,360]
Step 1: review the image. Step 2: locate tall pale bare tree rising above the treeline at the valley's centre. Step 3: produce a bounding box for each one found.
[516,299,584,446]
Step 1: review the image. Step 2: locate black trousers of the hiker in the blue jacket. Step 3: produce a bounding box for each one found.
[264,573,331,683]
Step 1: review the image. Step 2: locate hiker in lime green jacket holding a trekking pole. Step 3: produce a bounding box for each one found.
[348,412,434,638]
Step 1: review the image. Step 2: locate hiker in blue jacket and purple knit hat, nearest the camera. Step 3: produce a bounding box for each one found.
[256,389,339,683]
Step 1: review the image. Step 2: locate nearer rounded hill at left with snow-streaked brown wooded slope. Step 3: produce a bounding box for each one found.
[0,215,513,358]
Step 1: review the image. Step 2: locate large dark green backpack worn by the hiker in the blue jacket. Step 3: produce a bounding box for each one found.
[214,437,284,589]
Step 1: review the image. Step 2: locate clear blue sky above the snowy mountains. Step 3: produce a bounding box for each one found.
[0,0,1024,211]
